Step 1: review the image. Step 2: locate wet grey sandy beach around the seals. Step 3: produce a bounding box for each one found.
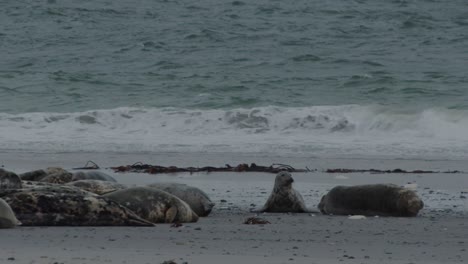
[0,152,468,263]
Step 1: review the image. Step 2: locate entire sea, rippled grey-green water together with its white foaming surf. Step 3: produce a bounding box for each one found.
[0,0,468,160]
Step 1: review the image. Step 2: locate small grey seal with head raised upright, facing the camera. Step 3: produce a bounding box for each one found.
[260,171,311,213]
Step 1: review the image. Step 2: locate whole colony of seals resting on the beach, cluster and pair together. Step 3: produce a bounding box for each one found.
[0,168,424,228]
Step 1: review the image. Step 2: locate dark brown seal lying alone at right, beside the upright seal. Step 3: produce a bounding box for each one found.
[318,184,424,216]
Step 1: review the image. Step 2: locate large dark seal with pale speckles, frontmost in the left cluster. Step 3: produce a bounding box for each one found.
[1,186,154,226]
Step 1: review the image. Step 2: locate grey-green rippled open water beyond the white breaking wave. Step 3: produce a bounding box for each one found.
[0,0,468,113]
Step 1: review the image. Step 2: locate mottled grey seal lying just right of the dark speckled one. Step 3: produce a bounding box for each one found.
[103,187,198,223]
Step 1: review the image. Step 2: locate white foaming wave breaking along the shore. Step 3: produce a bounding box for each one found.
[0,105,468,158]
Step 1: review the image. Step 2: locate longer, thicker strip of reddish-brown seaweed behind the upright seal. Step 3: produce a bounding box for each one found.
[111,162,311,174]
